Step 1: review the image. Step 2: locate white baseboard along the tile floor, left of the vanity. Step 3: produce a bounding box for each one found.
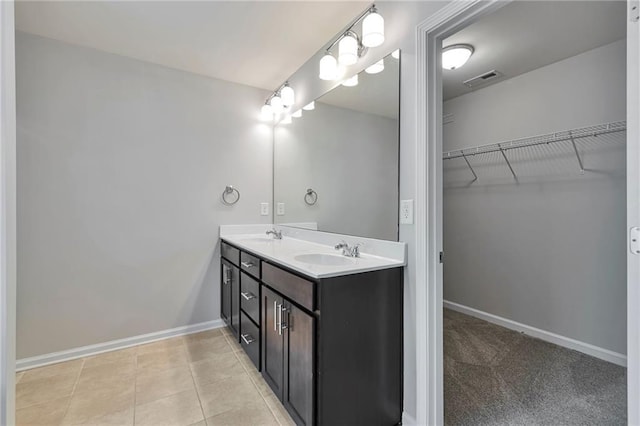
[16,319,225,371]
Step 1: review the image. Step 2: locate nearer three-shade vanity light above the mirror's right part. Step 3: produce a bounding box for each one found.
[319,5,384,80]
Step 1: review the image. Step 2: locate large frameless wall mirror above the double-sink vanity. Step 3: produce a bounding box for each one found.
[274,51,400,241]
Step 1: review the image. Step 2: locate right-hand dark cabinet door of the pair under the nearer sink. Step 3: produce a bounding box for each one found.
[282,303,315,425]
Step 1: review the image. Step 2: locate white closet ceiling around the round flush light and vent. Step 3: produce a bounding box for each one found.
[442,1,626,100]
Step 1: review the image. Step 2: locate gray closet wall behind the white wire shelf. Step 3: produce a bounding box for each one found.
[444,40,626,354]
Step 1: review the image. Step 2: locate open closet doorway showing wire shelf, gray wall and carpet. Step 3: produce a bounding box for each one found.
[420,1,627,425]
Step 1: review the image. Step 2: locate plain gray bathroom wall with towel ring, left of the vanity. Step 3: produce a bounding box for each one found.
[16,33,272,358]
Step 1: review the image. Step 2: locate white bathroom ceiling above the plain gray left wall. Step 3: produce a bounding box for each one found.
[16,0,369,90]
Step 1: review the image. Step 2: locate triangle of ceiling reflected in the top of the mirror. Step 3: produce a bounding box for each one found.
[318,55,400,120]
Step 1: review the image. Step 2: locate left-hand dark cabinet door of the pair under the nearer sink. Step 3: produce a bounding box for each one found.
[262,286,284,399]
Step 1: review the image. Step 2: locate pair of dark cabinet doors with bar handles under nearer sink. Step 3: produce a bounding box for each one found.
[262,286,315,425]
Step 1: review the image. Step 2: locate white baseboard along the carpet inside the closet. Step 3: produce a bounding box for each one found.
[443,300,627,367]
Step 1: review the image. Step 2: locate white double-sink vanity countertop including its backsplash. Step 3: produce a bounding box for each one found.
[220,225,406,278]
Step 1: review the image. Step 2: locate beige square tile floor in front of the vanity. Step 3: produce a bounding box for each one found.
[16,329,294,426]
